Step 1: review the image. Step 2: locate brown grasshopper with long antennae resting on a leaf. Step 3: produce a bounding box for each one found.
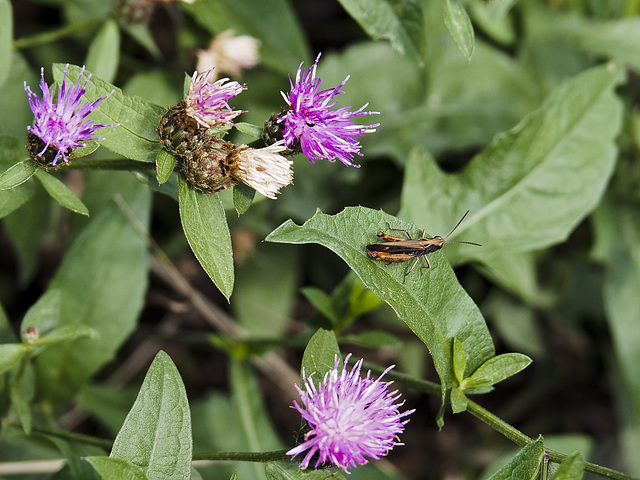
[367,210,482,283]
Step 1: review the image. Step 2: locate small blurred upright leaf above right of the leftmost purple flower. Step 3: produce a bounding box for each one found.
[85,18,120,82]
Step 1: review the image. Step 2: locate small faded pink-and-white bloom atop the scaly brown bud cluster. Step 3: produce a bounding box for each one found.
[184,69,247,128]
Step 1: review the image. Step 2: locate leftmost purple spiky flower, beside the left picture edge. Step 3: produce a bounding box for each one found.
[24,64,117,165]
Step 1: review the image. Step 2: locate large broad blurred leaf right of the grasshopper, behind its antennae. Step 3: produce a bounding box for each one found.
[400,65,622,263]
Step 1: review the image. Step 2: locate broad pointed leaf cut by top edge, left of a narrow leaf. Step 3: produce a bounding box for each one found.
[340,0,425,65]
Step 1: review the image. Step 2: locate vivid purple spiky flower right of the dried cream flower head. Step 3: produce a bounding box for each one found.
[281,54,380,167]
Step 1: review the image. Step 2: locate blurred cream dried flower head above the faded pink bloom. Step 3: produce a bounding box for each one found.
[197,30,260,81]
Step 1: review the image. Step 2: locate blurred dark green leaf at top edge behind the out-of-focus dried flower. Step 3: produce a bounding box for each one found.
[182,0,310,74]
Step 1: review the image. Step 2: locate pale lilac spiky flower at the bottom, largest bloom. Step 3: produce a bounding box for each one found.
[287,354,414,473]
